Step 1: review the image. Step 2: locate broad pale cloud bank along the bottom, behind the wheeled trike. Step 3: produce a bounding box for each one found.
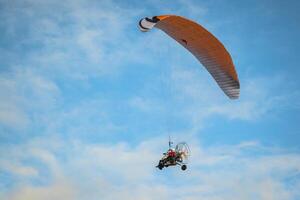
[2,138,300,200]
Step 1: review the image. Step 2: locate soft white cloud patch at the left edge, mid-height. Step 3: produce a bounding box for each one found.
[0,68,60,131]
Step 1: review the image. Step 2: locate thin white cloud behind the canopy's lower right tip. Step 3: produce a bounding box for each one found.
[169,63,298,130]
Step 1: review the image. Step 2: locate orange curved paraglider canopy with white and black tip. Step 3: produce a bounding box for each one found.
[139,15,240,99]
